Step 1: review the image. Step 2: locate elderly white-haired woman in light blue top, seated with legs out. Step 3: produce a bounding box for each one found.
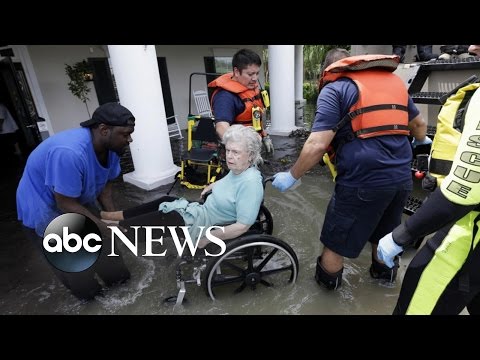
[101,125,263,248]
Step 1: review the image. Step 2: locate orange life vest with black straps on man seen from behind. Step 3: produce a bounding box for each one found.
[320,55,410,139]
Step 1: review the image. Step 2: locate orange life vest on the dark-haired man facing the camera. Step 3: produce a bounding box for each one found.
[208,73,264,126]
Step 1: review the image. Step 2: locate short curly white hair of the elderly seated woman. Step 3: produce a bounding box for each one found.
[222,125,262,165]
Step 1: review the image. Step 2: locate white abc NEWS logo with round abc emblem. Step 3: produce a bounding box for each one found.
[43,213,226,273]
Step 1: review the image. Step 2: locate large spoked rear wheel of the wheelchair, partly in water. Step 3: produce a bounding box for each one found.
[203,234,298,300]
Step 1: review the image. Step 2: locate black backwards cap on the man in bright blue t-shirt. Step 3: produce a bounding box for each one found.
[80,102,135,127]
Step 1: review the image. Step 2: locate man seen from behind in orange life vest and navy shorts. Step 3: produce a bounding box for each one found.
[272,49,431,289]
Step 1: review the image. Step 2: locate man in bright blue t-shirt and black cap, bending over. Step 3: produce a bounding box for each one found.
[17,103,135,299]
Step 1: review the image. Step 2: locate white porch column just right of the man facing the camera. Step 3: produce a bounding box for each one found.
[268,45,296,135]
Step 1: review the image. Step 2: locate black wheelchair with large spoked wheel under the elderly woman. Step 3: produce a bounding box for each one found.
[165,178,299,305]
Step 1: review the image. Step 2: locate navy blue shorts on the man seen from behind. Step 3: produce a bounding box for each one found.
[320,180,412,258]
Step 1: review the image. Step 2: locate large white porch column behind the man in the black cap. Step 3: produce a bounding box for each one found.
[108,45,179,190]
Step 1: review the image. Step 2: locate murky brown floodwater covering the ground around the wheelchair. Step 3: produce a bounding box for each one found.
[0,104,420,315]
